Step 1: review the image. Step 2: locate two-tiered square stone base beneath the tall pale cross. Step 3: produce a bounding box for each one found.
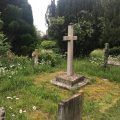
[51,73,89,90]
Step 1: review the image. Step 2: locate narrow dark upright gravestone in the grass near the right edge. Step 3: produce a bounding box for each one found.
[103,43,109,68]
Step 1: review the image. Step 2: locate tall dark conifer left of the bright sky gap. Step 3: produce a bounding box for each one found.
[0,0,36,55]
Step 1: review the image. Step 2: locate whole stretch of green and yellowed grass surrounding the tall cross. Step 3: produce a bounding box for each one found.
[0,58,120,120]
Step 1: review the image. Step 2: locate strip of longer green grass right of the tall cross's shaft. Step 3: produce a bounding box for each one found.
[74,58,120,82]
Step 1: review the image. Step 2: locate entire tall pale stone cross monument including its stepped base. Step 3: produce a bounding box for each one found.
[51,24,89,90]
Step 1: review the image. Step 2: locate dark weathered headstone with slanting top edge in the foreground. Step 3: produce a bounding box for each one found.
[57,93,83,120]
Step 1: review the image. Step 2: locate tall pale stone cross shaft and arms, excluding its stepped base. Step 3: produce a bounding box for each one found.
[63,24,77,76]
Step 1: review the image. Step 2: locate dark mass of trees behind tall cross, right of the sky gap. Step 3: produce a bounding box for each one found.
[47,0,120,56]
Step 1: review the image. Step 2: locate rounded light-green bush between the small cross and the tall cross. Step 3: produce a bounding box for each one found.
[38,40,63,67]
